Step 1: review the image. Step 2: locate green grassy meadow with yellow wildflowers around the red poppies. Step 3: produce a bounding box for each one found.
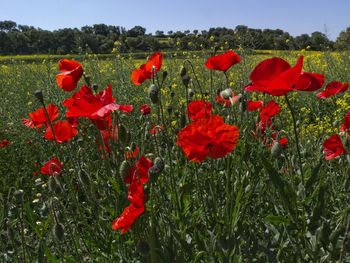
[0,49,350,262]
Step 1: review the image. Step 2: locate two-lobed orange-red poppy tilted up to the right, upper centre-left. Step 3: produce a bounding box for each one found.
[131,52,163,85]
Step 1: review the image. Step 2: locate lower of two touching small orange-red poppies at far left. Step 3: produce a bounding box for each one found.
[43,121,78,143]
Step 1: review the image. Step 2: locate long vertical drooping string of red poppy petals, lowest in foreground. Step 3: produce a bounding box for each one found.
[112,155,153,233]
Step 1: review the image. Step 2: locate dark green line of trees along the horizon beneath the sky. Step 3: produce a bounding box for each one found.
[0,20,350,55]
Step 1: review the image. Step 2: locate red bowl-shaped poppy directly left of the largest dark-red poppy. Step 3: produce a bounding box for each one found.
[205,50,241,71]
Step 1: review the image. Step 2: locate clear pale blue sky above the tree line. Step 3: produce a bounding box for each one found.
[0,0,350,40]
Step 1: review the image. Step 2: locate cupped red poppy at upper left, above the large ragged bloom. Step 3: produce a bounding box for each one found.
[56,59,83,91]
